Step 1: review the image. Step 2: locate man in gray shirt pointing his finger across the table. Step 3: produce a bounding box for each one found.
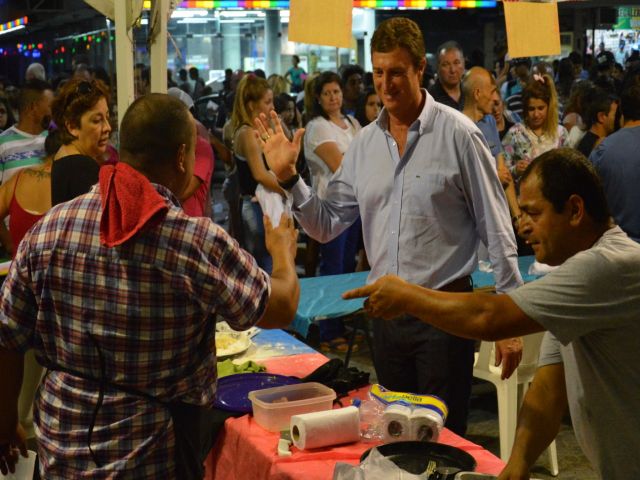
[344,148,640,480]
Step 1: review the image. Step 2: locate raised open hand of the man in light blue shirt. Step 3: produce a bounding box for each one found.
[254,110,304,182]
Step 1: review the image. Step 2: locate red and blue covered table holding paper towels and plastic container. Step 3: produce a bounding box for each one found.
[205,330,504,480]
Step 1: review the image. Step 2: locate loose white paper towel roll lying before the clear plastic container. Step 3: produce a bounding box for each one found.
[291,406,360,450]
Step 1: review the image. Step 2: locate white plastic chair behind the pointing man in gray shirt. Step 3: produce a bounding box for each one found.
[473,333,558,477]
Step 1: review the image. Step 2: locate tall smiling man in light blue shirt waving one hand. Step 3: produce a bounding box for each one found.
[259,18,522,434]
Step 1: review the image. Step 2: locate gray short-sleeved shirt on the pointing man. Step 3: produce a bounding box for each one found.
[508,227,640,480]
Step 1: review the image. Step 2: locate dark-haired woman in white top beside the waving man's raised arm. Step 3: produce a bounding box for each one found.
[304,72,362,350]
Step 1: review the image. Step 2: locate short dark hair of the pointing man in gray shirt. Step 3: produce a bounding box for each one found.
[521,147,611,224]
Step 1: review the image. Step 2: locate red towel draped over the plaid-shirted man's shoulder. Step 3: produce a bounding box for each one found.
[100,162,169,247]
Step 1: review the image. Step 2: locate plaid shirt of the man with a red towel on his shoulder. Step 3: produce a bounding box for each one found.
[0,186,269,478]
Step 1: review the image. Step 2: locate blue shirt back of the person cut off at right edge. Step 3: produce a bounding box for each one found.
[589,127,640,242]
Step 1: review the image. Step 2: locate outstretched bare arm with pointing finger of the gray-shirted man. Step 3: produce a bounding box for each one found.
[342,275,544,340]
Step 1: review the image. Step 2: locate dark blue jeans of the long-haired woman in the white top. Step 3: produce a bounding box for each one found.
[318,218,362,342]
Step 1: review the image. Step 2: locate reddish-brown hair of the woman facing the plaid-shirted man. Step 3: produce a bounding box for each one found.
[51,77,109,145]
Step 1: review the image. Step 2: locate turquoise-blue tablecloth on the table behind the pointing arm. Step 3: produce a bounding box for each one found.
[289,256,538,337]
